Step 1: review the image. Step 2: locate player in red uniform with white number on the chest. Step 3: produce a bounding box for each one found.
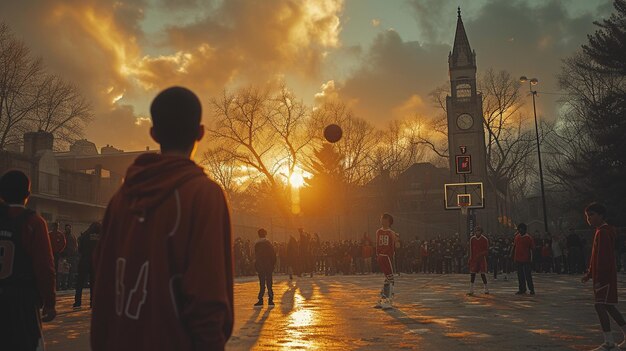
[375,213,396,309]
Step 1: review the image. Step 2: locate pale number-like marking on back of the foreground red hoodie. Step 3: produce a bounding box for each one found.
[115,257,150,319]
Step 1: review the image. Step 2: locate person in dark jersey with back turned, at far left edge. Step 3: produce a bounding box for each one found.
[0,171,56,350]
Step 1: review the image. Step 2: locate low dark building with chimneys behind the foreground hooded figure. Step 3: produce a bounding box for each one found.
[0,131,149,233]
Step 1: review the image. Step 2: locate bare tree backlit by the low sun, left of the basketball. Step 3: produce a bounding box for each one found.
[205,86,311,215]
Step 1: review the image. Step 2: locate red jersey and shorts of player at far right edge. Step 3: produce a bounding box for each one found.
[589,224,617,303]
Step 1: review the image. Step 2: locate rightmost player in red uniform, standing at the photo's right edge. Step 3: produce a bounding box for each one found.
[582,203,626,351]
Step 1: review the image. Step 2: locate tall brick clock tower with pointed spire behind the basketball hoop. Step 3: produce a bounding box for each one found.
[446,8,487,185]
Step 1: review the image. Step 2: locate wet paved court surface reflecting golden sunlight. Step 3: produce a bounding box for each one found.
[45,274,626,351]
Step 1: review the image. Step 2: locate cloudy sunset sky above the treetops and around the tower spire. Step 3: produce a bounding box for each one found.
[0,0,612,151]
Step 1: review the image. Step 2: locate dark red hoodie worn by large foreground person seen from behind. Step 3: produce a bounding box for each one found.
[91,154,234,351]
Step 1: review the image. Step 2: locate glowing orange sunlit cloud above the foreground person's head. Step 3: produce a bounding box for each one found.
[0,0,343,153]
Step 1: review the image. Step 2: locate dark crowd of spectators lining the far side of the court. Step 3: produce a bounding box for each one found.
[234,230,626,279]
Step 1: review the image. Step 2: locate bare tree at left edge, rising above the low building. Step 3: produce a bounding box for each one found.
[0,23,92,150]
